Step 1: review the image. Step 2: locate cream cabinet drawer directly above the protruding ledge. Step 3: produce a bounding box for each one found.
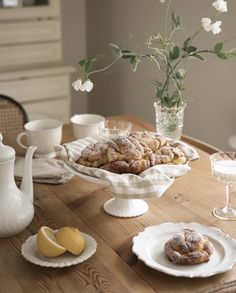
[0,42,62,69]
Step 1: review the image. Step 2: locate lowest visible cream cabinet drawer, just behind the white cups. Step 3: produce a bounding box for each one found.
[23,98,70,124]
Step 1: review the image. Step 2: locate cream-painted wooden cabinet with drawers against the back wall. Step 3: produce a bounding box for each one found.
[0,0,74,123]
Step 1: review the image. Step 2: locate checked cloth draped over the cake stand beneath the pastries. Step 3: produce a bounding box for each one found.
[61,137,199,198]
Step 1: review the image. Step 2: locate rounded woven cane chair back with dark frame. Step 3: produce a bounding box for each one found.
[0,95,29,135]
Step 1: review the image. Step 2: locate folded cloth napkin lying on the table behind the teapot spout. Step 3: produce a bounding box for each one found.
[14,157,74,184]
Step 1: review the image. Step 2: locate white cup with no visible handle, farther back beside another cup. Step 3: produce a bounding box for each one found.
[70,114,105,139]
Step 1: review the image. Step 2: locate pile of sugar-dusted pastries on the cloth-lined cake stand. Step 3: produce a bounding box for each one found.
[76,131,187,174]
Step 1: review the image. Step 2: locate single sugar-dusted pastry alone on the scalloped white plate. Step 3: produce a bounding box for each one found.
[164,229,214,265]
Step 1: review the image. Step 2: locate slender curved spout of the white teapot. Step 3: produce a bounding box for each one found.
[20,146,37,202]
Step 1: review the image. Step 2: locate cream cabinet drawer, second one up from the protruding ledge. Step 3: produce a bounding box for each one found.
[0,20,60,45]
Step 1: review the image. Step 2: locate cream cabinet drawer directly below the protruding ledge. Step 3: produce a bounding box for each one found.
[0,75,70,103]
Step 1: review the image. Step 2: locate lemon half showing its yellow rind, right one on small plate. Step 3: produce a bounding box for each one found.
[55,227,85,255]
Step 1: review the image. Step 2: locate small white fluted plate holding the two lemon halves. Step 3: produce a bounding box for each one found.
[21,232,97,268]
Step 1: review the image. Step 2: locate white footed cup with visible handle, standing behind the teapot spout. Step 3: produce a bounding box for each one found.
[16,119,63,158]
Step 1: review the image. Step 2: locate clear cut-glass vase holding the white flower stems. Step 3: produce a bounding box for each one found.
[154,102,186,140]
